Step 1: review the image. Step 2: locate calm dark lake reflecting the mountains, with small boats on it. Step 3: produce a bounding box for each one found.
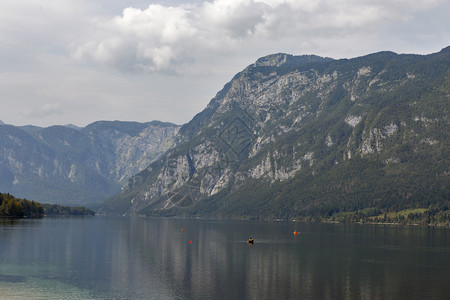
[0,216,450,300]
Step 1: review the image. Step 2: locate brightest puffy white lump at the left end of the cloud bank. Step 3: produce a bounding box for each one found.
[74,5,196,72]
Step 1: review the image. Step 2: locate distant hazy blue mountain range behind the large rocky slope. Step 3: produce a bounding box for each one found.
[0,121,179,207]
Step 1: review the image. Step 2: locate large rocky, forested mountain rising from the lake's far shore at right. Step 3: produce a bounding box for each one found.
[101,47,450,219]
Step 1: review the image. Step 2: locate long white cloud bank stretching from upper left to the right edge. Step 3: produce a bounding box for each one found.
[73,0,448,72]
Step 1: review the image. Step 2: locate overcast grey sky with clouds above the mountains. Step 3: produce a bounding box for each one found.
[0,0,450,126]
